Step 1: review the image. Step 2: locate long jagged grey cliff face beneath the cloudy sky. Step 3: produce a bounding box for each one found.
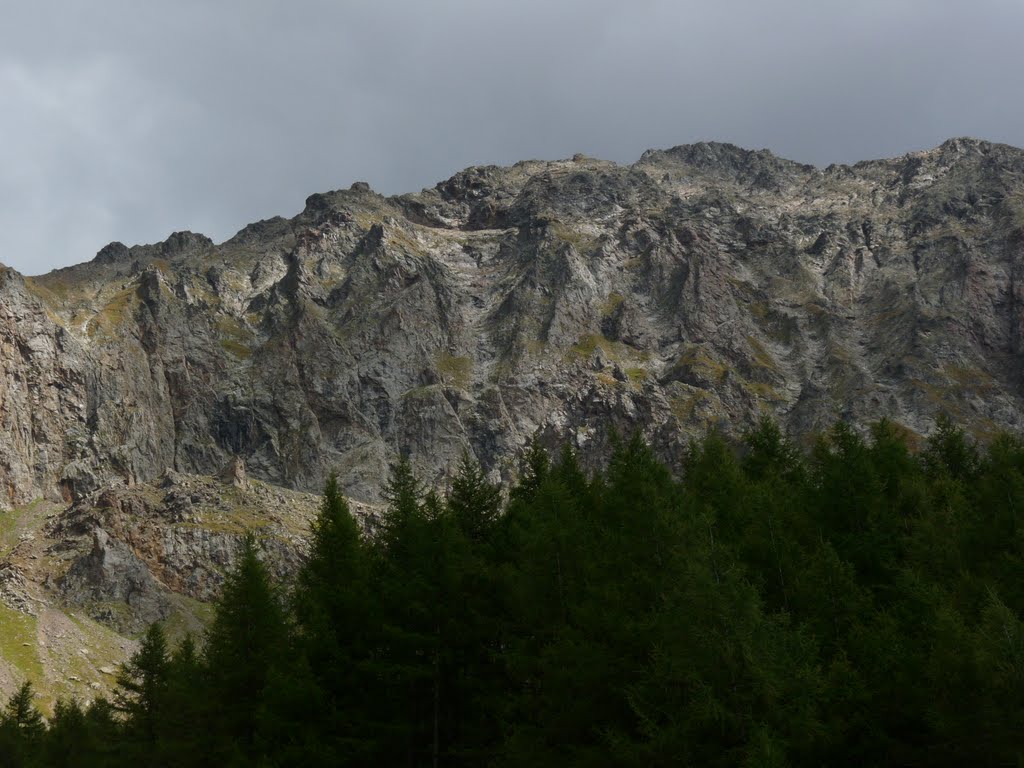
[0,139,1024,507]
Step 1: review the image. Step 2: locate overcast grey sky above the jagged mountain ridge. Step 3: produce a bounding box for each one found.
[0,0,1024,274]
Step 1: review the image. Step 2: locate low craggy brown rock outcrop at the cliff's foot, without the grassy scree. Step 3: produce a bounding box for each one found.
[48,473,323,633]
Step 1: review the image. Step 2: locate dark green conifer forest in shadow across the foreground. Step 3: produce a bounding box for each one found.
[0,420,1024,767]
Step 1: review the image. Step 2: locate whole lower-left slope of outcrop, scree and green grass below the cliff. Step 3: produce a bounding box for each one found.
[0,462,329,709]
